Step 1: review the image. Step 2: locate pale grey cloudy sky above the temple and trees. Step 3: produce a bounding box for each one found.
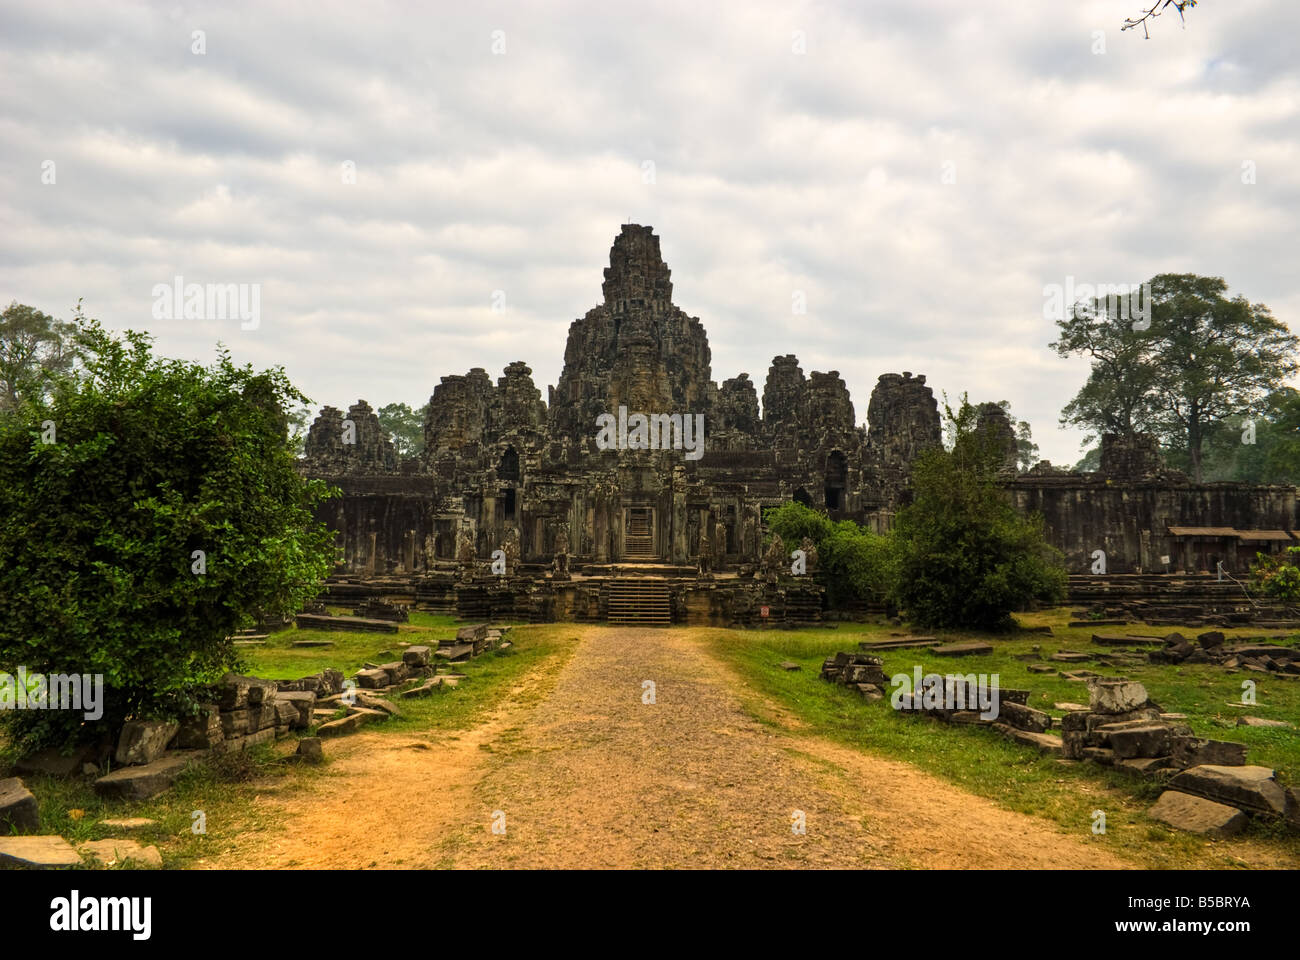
[0,0,1300,463]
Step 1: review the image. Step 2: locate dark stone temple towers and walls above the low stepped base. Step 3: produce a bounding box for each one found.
[302,224,1296,576]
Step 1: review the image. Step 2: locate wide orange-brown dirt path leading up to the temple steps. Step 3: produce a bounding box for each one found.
[220,627,1125,868]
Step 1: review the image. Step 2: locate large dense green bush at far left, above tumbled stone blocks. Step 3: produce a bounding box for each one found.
[0,321,335,744]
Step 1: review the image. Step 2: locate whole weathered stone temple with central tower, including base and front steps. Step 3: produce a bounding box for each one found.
[302,224,1300,624]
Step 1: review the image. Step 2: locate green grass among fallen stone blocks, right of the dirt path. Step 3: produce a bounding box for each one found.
[707,609,1300,868]
